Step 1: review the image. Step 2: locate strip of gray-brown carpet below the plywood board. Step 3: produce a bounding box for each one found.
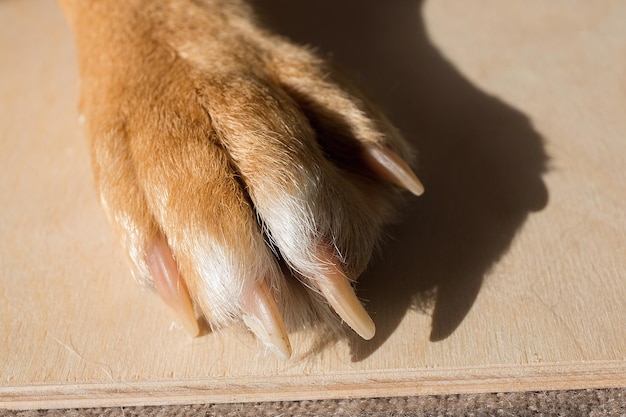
[0,388,626,417]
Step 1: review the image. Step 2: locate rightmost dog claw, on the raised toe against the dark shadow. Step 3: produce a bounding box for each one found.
[364,144,424,196]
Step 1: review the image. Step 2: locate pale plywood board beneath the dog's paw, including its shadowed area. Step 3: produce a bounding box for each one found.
[0,0,626,408]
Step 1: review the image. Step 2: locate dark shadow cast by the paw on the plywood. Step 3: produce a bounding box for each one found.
[256,0,548,361]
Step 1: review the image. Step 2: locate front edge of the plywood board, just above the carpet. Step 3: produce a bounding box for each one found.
[0,361,626,409]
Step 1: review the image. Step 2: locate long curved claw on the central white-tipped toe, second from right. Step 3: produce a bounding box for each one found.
[315,245,376,340]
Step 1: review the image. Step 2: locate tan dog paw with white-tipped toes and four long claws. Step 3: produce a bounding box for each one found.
[66,0,423,358]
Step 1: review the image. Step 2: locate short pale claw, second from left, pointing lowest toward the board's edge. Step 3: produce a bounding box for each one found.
[243,281,291,360]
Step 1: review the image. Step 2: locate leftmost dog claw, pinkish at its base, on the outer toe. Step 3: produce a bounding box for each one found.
[146,236,200,337]
